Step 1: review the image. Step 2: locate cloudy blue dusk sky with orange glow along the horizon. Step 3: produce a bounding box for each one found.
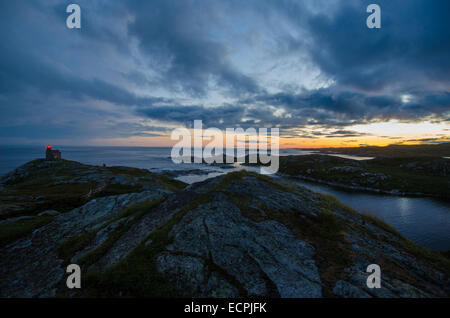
[0,0,450,148]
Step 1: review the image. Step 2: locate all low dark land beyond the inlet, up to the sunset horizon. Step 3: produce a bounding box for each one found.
[246,143,450,199]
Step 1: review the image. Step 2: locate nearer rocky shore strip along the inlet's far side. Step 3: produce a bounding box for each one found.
[279,154,450,200]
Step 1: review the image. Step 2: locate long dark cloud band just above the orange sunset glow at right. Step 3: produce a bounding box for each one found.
[242,88,450,126]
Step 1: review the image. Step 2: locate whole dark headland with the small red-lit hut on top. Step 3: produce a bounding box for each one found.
[0,159,185,220]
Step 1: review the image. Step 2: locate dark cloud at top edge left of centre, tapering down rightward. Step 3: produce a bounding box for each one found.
[125,0,259,95]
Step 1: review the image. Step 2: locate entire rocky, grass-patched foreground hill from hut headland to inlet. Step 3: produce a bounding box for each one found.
[0,160,450,297]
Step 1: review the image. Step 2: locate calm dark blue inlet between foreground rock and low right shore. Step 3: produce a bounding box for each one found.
[295,180,450,251]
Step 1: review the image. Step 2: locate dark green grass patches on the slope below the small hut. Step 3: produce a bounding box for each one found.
[0,159,186,246]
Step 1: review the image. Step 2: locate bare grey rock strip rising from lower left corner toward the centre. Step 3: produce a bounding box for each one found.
[0,192,165,297]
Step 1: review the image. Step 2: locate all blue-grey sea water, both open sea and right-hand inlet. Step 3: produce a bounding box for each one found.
[0,146,450,250]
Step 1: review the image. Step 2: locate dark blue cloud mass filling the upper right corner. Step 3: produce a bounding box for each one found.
[300,0,450,91]
